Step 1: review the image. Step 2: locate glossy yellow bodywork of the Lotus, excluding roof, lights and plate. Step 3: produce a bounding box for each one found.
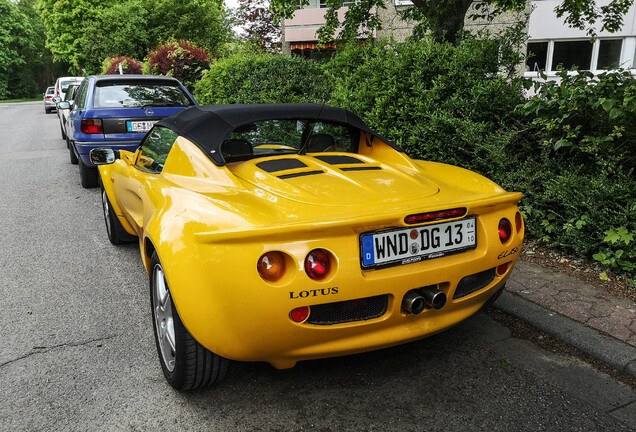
[100,134,524,368]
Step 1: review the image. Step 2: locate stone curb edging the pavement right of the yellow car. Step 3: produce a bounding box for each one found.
[493,291,636,378]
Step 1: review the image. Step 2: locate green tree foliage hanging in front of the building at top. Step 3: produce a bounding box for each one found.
[271,0,633,43]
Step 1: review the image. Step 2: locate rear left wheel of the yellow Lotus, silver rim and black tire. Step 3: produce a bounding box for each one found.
[150,252,230,391]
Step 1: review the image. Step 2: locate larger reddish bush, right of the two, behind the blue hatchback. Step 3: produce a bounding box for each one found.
[148,41,210,88]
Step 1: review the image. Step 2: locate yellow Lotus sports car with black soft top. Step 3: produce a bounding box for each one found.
[91,104,524,390]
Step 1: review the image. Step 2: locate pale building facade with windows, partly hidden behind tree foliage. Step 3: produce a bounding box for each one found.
[283,0,636,77]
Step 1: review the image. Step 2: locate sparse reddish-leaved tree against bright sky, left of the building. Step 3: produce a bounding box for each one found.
[236,0,281,54]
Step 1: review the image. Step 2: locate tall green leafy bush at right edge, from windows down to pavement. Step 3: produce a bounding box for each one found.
[509,71,636,274]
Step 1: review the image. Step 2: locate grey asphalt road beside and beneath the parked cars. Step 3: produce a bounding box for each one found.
[0,103,636,432]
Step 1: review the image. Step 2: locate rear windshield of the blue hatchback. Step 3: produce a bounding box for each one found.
[93,81,194,108]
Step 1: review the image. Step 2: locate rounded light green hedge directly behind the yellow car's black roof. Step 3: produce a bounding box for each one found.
[195,54,331,104]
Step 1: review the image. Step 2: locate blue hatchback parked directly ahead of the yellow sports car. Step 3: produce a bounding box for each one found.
[60,75,197,188]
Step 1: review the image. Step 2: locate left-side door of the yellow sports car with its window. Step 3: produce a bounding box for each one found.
[113,126,177,238]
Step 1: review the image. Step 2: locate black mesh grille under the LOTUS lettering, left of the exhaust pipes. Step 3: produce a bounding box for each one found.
[306,295,389,325]
